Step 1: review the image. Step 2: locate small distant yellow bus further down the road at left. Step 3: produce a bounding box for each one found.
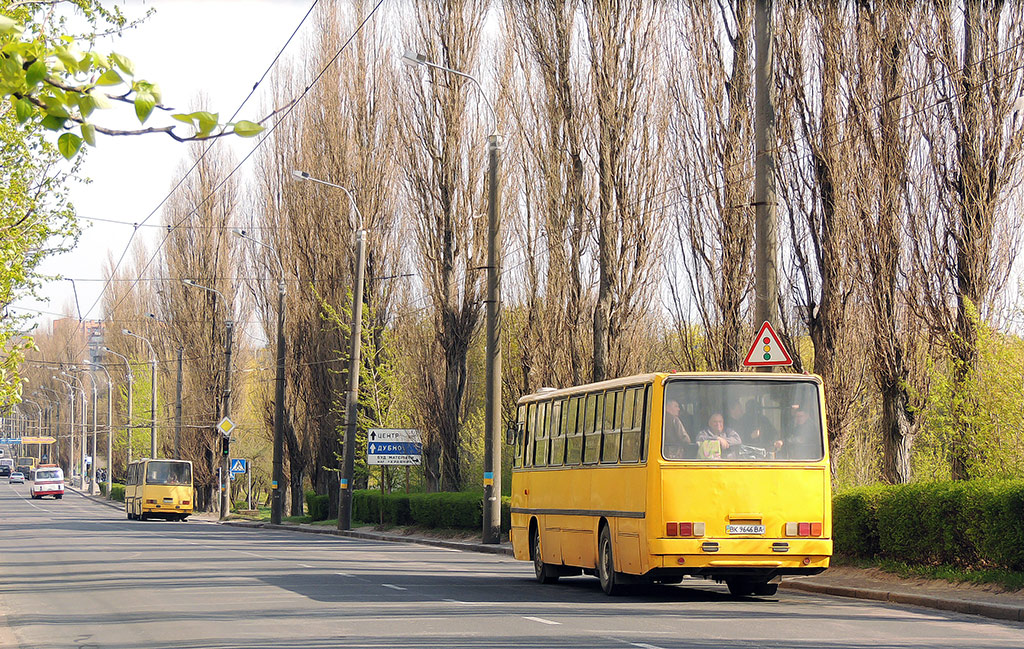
[125,460,195,521]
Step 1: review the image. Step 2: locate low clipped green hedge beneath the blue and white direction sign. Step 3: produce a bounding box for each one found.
[352,489,512,529]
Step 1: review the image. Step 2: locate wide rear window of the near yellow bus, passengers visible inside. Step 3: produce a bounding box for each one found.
[662,378,824,462]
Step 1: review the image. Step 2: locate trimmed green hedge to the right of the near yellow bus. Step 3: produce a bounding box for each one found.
[833,480,1024,570]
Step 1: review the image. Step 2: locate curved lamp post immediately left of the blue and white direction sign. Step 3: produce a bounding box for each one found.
[292,170,367,529]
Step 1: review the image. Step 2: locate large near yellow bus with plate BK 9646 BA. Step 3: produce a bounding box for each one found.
[508,373,833,597]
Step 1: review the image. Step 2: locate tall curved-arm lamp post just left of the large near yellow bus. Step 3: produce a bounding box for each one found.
[402,50,502,544]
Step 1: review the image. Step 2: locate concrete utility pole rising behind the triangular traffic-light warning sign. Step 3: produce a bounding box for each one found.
[754,0,778,372]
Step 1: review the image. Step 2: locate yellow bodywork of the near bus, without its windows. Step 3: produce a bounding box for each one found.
[511,373,833,595]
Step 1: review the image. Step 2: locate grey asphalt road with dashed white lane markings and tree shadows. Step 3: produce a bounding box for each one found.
[0,482,1024,649]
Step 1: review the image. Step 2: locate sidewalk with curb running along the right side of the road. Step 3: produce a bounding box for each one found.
[223,521,1024,621]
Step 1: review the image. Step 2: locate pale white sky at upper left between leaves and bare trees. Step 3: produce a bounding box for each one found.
[13,0,316,331]
